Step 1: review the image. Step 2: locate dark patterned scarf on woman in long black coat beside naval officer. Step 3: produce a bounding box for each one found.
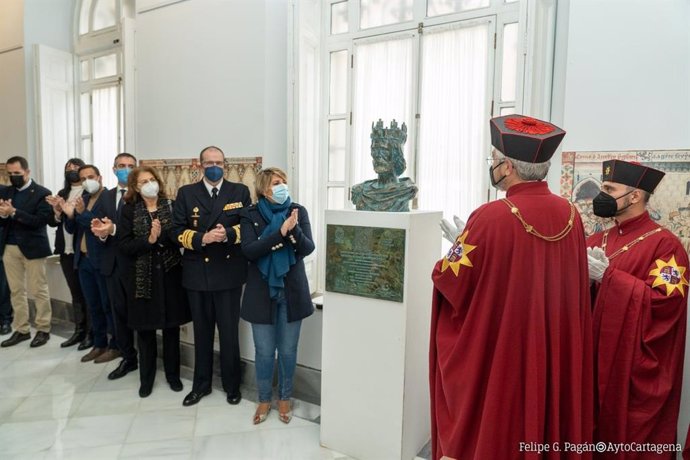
[132,199,182,299]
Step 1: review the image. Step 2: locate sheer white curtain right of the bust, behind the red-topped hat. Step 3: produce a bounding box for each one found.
[417,22,492,228]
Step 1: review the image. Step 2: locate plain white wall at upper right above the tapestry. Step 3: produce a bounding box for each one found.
[549,0,690,443]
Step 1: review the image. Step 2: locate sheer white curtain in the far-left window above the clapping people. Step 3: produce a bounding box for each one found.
[92,85,119,188]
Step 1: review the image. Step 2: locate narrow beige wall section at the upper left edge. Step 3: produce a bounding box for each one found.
[0,0,27,162]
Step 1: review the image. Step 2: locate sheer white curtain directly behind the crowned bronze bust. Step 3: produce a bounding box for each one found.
[350,34,416,185]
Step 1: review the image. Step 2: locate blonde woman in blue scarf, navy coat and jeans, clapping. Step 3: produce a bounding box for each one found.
[240,168,314,425]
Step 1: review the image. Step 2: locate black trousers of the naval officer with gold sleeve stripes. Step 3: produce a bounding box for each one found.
[187,288,242,395]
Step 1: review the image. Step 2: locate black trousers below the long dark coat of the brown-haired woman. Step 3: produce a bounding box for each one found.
[137,326,180,388]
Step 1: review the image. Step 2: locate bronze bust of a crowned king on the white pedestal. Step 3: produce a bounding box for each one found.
[350,119,418,212]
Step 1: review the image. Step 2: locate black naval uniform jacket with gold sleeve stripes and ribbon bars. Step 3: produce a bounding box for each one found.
[173,179,251,291]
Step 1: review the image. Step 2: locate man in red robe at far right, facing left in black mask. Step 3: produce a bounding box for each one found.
[587,160,688,460]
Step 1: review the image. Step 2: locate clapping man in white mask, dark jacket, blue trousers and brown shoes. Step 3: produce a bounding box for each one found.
[62,165,120,363]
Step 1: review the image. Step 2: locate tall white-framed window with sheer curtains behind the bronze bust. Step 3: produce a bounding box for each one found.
[298,0,555,292]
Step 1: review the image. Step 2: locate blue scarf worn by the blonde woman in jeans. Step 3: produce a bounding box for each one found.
[256,197,297,299]
